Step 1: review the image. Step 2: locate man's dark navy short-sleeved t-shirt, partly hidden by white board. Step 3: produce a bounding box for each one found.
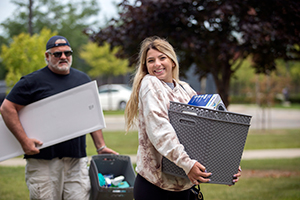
[6,67,91,159]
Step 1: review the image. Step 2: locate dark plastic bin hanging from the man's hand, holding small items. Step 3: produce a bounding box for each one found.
[89,154,135,200]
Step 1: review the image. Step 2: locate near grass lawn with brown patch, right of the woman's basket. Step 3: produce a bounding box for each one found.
[201,158,300,200]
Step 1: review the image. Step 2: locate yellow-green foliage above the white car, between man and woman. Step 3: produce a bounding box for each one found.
[80,42,128,78]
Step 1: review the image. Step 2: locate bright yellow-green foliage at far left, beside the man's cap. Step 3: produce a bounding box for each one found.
[0,29,55,90]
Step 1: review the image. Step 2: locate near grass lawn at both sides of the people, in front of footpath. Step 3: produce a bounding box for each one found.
[0,158,300,200]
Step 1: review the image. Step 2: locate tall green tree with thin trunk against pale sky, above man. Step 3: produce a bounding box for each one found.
[0,0,99,71]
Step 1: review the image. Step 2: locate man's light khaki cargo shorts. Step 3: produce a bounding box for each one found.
[25,157,91,200]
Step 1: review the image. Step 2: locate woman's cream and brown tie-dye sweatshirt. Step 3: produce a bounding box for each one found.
[136,75,196,191]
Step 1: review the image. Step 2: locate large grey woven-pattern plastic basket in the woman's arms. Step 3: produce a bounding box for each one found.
[162,102,251,185]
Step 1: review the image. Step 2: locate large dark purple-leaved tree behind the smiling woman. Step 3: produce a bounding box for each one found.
[86,0,300,106]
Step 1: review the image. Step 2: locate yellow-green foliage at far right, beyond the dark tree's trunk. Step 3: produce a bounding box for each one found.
[230,56,300,105]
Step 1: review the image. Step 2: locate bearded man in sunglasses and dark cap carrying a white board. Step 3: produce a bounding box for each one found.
[0,36,117,200]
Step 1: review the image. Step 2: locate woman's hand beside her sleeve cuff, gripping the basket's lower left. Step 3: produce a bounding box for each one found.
[188,162,212,185]
